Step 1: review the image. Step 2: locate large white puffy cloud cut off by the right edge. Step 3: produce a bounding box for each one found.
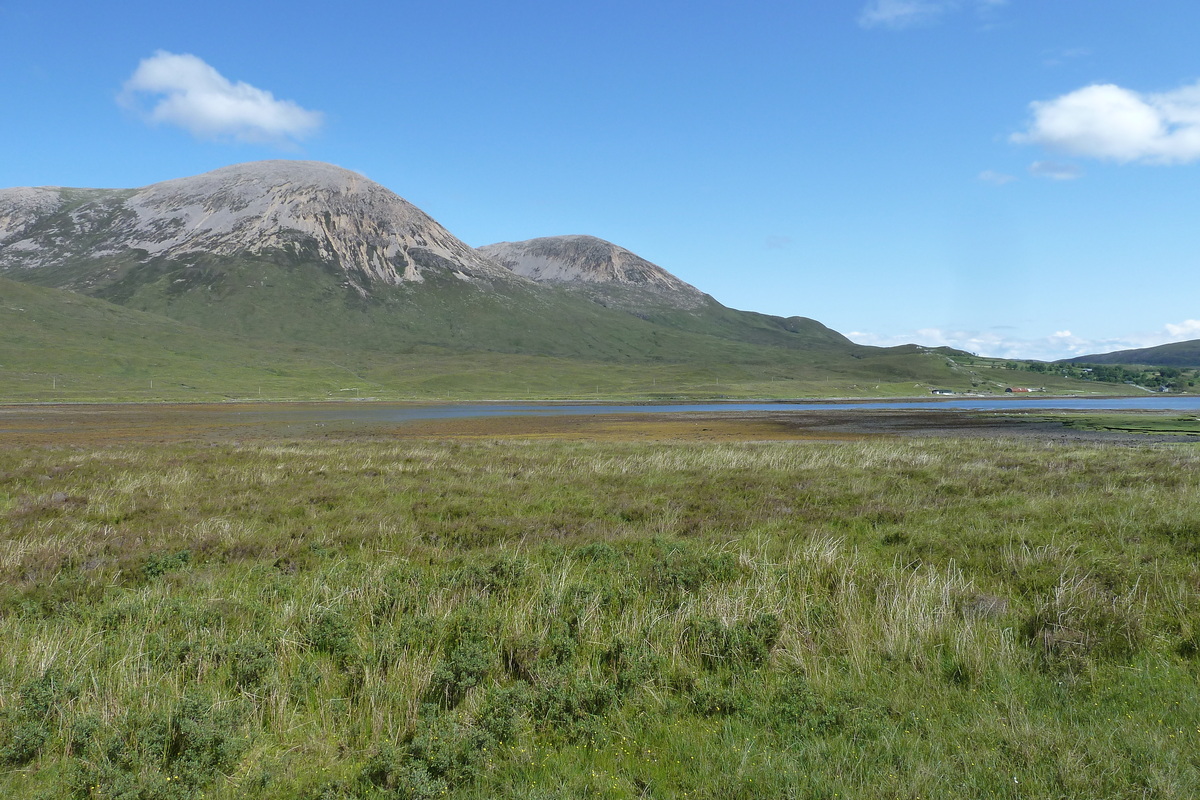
[1010,82,1200,164]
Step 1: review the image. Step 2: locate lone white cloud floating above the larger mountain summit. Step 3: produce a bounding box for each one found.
[119,50,323,143]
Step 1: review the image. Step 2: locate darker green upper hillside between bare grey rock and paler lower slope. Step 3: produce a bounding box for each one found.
[7,244,865,363]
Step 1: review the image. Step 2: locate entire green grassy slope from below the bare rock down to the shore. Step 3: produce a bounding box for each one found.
[0,258,1128,401]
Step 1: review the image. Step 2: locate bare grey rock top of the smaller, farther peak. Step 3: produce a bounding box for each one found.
[479,235,712,308]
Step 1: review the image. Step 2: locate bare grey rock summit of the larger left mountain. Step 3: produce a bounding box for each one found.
[0,161,512,291]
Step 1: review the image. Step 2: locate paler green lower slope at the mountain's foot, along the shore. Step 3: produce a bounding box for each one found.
[0,278,969,401]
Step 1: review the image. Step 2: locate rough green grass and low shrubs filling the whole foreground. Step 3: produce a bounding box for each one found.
[0,439,1200,800]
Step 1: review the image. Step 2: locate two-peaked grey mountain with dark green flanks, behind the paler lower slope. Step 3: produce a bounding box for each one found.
[0,161,984,393]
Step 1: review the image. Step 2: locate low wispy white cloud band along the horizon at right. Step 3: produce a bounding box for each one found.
[846,319,1200,361]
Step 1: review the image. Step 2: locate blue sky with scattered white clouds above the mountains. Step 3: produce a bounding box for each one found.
[0,0,1200,359]
